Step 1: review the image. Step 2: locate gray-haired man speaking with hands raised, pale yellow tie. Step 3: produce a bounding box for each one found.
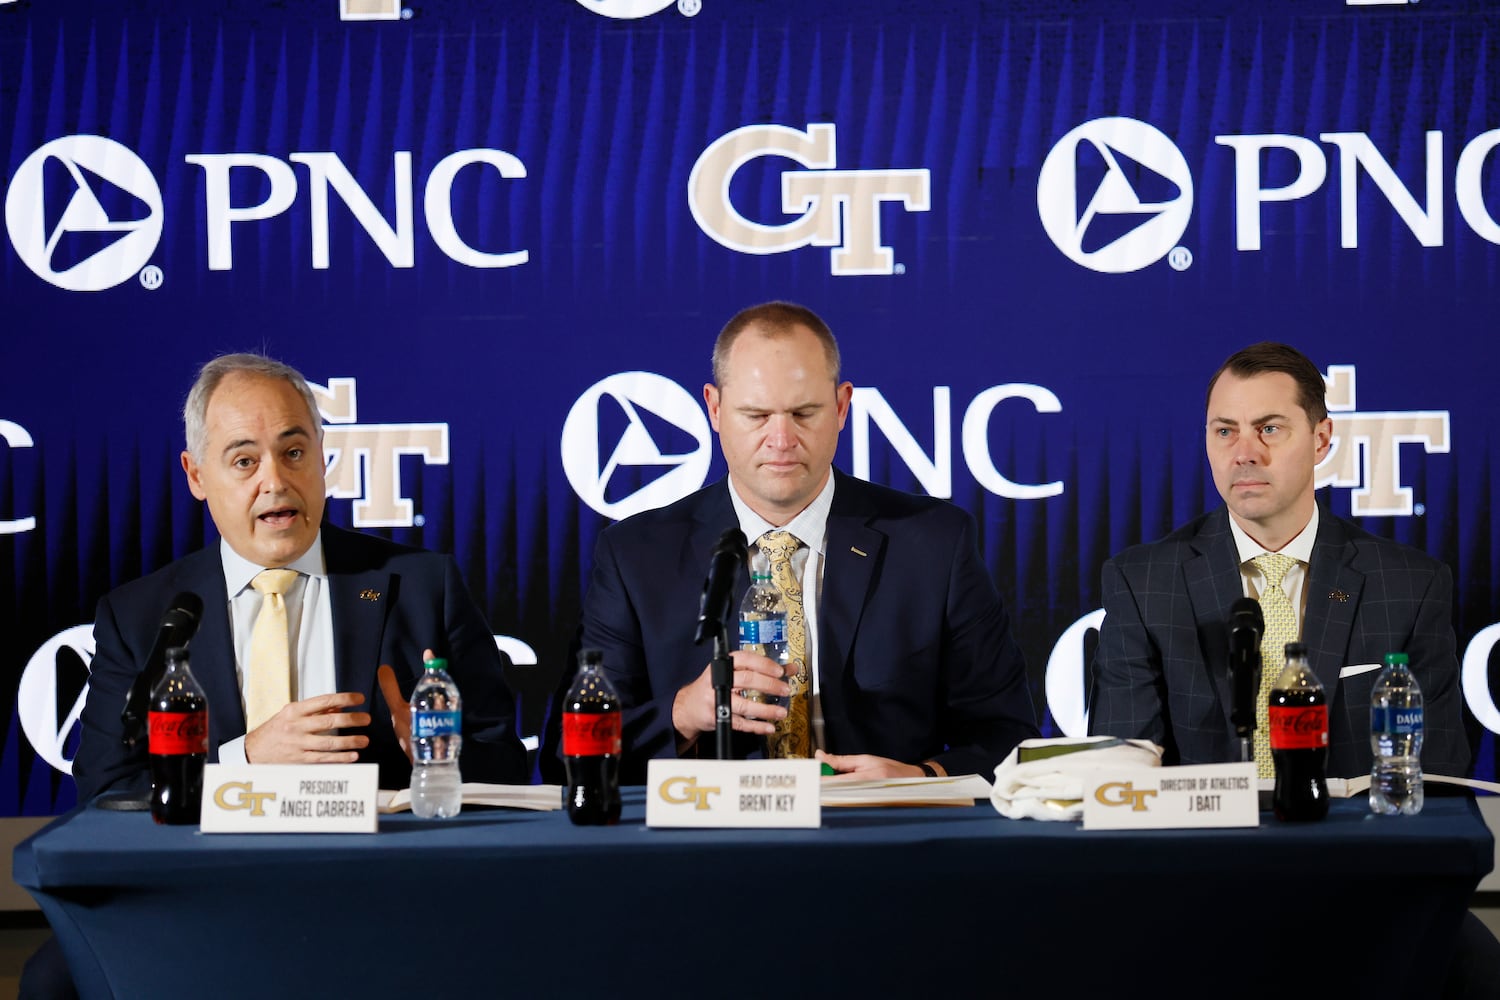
[74,354,528,801]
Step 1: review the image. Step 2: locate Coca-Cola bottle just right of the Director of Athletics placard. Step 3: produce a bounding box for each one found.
[1266,642,1328,820]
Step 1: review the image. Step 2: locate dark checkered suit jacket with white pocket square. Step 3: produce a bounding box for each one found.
[1089,507,1470,778]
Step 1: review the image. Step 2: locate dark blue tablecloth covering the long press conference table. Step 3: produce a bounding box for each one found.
[14,789,1494,999]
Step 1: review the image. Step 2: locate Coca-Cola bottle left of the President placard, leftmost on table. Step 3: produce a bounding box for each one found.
[147,646,209,825]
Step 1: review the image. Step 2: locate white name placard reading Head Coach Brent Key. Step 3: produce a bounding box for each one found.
[647,760,824,828]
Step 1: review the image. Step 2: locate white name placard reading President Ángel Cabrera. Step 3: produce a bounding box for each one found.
[200,765,380,834]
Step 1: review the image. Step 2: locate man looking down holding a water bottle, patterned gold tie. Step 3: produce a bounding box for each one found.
[582,303,1037,784]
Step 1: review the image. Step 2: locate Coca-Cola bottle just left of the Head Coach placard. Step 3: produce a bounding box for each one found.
[563,649,620,826]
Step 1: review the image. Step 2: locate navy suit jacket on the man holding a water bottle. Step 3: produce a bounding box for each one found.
[582,472,1037,784]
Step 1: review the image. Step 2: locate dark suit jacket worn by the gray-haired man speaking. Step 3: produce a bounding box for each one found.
[74,523,528,801]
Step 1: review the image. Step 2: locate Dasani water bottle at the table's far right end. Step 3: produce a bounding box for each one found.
[1370,652,1422,816]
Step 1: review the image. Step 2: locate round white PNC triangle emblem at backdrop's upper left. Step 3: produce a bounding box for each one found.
[5,135,162,292]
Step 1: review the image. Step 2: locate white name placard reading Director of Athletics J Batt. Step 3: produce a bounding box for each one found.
[1083,763,1260,831]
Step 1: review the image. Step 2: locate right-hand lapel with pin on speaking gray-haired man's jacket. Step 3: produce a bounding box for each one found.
[323,525,399,694]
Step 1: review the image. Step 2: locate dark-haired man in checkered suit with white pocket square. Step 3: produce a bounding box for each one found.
[1089,343,1470,777]
